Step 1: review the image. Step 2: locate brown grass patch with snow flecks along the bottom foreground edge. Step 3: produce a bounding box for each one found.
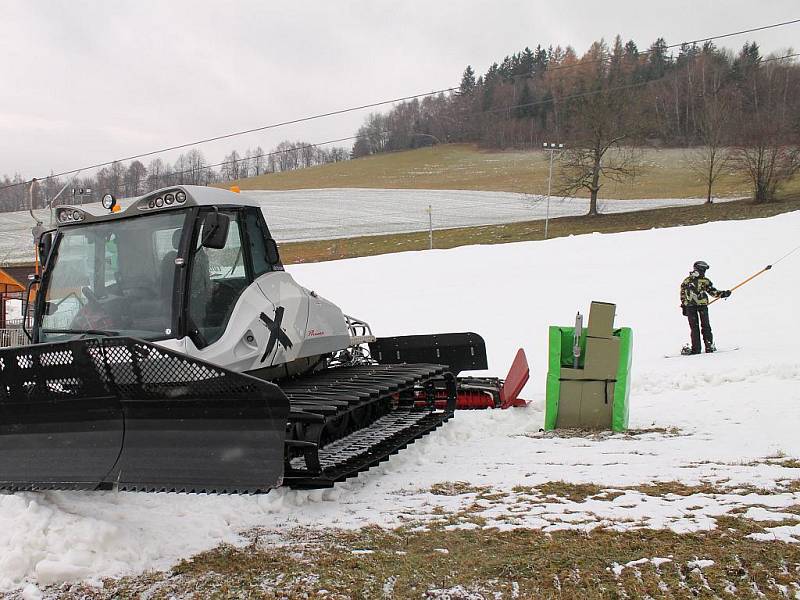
[57,517,800,600]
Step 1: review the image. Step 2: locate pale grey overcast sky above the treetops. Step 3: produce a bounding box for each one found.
[0,0,800,177]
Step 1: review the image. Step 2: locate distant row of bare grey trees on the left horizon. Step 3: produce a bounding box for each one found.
[0,141,350,212]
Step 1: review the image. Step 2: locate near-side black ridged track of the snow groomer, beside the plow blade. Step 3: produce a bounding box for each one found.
[281,364,456,488]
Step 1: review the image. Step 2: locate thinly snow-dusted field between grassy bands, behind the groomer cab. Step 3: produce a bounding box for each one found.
[0,188,732,264]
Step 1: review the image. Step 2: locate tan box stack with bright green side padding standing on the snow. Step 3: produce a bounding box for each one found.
[545,302,633,431]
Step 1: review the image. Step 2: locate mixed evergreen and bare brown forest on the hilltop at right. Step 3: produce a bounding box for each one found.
[353,36,800,213]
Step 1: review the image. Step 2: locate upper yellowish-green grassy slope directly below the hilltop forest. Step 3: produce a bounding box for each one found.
[225,144,800,198]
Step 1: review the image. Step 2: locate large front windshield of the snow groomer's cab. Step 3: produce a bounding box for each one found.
[39,211,187,342]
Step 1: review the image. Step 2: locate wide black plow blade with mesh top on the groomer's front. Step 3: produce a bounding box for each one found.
[0,337,289,493]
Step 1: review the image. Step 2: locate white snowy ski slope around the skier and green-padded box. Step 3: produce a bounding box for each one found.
[0,212,800,592]
